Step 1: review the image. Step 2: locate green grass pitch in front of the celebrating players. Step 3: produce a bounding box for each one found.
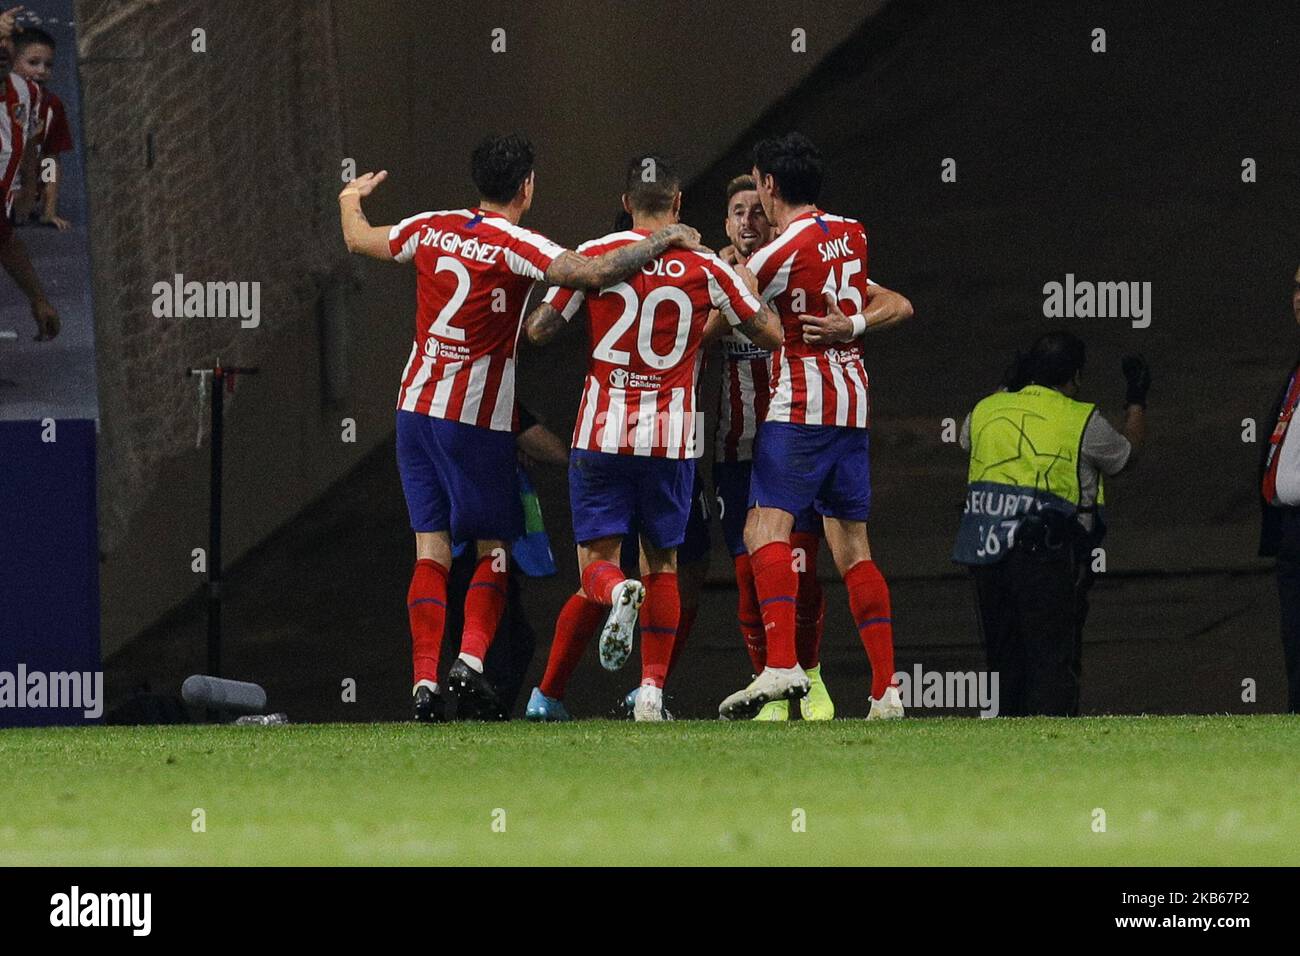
[0,715,1300,865]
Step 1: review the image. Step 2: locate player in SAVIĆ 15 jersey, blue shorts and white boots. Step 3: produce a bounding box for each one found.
[719,133,911,718]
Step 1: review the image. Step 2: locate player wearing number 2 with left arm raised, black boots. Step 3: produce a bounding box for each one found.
[339,134,699,721]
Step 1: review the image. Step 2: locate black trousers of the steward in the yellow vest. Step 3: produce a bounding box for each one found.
[971,549,1091,717]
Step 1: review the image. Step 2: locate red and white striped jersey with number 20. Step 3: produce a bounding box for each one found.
[546,230,762,458]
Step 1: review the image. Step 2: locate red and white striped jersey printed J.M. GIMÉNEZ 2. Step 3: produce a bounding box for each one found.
[389,209,564,432]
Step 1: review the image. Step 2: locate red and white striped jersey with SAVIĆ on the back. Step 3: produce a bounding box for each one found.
[749,209,870,428]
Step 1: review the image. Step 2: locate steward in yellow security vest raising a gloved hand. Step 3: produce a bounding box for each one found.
[953,332,1151,717]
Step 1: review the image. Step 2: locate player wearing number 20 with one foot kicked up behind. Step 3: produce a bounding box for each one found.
[528,155,780,721]
